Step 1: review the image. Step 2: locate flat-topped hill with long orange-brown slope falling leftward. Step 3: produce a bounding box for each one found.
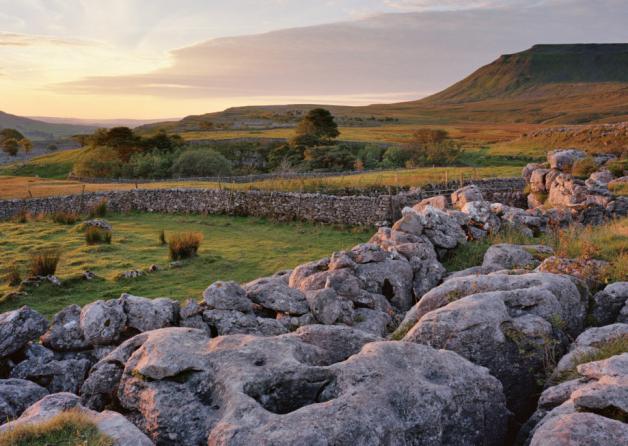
[140,43,628,133]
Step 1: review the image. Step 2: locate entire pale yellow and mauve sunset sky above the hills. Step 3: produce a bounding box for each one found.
[0,0,628,119]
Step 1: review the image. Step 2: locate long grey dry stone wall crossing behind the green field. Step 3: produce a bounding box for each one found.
[0,179,524,225]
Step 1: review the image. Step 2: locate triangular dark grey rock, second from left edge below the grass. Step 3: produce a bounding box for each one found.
[41,305,89,351]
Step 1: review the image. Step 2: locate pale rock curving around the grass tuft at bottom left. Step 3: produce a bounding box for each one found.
[0,393,153,446]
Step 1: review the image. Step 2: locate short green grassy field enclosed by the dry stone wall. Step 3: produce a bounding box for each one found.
[0,214,372,316]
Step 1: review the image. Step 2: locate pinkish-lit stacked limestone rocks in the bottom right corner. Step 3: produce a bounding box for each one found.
[519,324,628,446]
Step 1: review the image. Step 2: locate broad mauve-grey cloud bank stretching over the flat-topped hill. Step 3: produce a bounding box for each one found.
[52,0,628,104]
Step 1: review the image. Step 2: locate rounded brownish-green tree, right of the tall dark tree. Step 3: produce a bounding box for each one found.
[405,129,464,166]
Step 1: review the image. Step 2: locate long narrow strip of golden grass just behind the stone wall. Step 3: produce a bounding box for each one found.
[0,165,521,199]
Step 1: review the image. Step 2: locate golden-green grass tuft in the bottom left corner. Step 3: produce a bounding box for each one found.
[0,410,114,446]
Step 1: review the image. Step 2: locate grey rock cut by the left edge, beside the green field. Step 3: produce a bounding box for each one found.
[0,306,48,358]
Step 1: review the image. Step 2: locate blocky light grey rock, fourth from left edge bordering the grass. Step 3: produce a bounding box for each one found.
[120,293,179,332]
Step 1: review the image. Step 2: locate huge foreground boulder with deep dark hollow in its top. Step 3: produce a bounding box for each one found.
[79,325,507,445]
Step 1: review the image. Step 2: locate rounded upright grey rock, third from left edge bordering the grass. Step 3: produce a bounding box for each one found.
[80,300,126,345]
